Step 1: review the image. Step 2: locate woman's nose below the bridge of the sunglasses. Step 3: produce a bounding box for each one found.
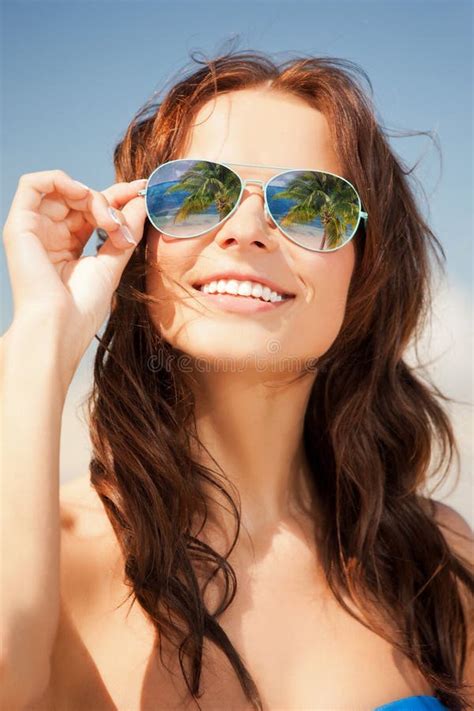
[215,181,278,252]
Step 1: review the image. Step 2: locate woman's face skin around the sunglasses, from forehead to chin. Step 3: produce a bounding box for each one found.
[147,88,355,369]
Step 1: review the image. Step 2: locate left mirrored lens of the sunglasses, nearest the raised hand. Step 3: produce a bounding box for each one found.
[146,159,241,237]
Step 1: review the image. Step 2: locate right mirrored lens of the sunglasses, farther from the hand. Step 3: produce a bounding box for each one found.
[267,170,360,251]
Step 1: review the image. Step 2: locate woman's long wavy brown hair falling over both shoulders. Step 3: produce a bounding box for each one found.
[88,49,474,709]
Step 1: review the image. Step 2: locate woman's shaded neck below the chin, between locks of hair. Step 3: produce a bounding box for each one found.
[190,371,315,537]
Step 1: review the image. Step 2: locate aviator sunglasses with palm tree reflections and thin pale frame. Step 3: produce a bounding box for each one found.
[138,158,368,252]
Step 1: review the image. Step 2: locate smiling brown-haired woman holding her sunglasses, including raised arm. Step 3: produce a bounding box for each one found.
[2,53,474,711]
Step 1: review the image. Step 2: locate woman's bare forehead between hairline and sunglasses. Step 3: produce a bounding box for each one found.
[179,88,341,174]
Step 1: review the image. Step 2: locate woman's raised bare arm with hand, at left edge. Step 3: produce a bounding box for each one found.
[0,171,145,711]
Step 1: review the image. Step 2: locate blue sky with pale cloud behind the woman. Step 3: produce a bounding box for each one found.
[0,0,473,513]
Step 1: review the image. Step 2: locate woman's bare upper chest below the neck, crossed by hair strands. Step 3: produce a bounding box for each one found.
[38,550,431,711]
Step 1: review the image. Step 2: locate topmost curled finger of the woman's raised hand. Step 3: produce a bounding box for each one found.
[12,170,89,210]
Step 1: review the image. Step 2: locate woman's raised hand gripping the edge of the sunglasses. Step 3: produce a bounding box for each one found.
[3,170,146,376]
